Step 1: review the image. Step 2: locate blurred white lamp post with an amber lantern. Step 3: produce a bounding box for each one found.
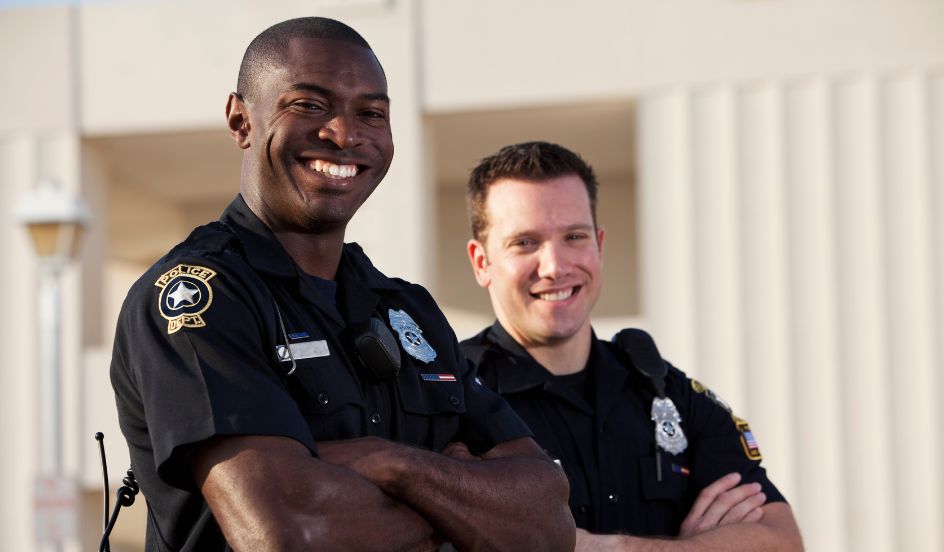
[15,180,89,550]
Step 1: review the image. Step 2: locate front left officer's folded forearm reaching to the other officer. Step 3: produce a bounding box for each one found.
[318,437,575,551]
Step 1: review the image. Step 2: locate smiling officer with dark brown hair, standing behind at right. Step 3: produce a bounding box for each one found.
[462,142,802,551]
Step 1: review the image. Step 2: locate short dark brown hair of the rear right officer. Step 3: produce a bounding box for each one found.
[465,142,598,241]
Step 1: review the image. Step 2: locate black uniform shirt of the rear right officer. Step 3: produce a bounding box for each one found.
[461,322,784,536]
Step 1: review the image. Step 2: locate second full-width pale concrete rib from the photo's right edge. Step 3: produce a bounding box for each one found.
[833,78,895,551]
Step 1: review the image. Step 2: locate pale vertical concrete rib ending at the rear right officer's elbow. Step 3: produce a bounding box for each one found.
[737,84,797,501]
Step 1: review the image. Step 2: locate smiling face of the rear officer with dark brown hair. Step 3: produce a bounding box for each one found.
[468,175,603,348]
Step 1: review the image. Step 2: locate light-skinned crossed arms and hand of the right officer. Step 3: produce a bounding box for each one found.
[576,473,803,552]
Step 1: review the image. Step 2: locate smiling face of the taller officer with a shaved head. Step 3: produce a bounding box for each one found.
[226,34,393,232]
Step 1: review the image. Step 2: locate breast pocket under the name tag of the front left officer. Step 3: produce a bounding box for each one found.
[288,356,366,441]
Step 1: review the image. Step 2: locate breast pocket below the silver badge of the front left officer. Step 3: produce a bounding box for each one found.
[397,365,465,452]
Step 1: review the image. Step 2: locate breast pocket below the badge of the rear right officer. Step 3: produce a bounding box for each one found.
[639,452,689,536]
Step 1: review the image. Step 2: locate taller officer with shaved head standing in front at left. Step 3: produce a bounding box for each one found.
[111,18,575,551]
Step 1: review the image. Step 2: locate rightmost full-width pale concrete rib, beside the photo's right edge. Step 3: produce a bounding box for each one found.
[881,76,944,550]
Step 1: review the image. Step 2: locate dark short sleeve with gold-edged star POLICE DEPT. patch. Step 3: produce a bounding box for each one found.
[112,256,315,488]
